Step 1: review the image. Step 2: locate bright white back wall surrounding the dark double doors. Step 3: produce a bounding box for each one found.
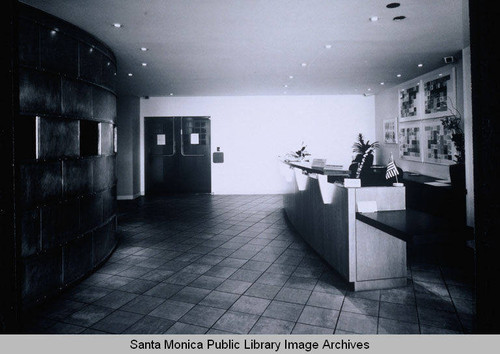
[141,95,375,194]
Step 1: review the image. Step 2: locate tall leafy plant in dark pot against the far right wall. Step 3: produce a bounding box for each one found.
[441,108,465,190]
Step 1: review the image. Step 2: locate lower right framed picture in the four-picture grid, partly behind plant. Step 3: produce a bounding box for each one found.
[423,119,454,165]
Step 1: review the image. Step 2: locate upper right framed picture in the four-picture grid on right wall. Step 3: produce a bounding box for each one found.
[422,67,457,119]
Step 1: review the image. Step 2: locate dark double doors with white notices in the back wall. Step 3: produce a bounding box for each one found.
[144,117,212,195]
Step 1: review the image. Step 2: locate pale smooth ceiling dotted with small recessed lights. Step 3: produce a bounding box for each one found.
[18,0,468,96]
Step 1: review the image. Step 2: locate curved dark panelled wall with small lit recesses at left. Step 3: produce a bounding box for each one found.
[14,4,117,309]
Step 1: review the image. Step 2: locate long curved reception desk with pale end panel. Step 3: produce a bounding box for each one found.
[283,163,407,291]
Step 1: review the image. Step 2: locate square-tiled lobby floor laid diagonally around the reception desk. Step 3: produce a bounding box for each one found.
[25,195,475,334]
